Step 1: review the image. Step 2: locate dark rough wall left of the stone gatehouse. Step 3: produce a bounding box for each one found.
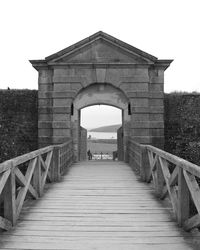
[0,90,38,162]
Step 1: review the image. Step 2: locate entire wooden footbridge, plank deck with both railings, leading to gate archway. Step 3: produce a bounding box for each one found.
[0,139,200,250]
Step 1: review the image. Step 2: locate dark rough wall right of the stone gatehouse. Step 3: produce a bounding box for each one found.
[164,93,200,165]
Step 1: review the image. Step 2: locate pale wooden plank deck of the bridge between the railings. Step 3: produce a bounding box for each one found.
[0,161,200,250]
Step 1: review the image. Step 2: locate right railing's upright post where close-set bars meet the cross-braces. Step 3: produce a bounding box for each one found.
[140,145,150,181]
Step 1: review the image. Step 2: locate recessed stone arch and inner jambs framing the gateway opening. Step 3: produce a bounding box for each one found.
[71,83,130,161]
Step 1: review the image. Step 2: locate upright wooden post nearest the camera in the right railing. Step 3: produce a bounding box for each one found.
[177,167,190,226]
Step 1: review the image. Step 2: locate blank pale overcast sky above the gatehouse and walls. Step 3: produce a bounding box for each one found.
[0,0,200,128]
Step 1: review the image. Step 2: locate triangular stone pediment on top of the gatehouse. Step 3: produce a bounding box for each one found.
[45,32,157,64]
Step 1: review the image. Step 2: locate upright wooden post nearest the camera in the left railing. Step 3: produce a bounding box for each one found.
[4,163,17,226]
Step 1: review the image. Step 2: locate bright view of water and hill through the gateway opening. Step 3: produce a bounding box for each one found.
[81,105,122,160]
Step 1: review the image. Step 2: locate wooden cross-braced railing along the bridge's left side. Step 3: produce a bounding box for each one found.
[0,141,73,230]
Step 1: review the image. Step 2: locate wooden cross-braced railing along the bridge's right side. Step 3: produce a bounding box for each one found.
[129,139,200,231]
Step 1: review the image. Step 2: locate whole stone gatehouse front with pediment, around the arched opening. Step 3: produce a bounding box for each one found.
[30,32,172,160]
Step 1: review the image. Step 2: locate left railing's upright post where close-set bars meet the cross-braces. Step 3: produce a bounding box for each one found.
[51,146,61,181]
